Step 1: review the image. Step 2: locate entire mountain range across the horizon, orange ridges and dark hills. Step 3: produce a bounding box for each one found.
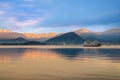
[0,28,120,45]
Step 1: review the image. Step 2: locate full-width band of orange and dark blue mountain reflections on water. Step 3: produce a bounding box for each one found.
[0,48,120,63]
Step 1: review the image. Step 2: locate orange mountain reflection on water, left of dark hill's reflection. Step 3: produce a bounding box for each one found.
[0,49,57,63]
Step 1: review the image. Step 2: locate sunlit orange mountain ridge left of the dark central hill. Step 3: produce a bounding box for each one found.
[0,29,57,39]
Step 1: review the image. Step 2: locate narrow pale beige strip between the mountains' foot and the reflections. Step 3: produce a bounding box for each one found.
[0,45,120,49]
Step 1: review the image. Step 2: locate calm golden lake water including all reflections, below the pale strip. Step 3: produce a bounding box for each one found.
[0,48,120,80]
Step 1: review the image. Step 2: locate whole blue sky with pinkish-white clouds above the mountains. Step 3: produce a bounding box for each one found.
[0,0,120,33]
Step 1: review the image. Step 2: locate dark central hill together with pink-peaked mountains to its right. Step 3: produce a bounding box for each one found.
[45,28,120,44]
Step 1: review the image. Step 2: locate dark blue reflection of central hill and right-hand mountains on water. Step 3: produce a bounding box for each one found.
[53,49,120,62]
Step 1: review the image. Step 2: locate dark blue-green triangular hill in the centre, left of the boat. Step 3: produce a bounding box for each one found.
[45,32,84,44]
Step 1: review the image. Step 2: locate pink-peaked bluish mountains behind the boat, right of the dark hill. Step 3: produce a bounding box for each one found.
[74,28,120,44]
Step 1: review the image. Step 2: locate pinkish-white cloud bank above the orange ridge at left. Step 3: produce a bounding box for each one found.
[0,12,48,32]
